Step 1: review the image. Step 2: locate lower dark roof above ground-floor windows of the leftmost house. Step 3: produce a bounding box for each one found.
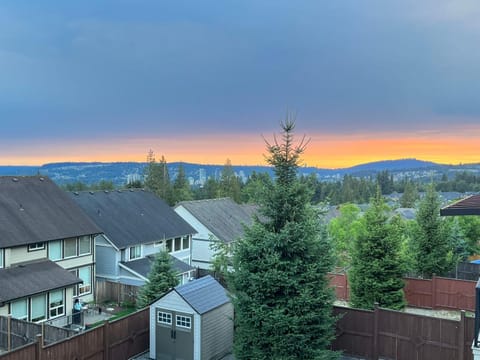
[0,260,82,304]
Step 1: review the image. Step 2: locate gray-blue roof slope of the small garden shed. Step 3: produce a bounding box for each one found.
[175,275,230,315]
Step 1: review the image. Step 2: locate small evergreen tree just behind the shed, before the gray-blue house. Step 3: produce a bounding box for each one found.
[137,251,178,308]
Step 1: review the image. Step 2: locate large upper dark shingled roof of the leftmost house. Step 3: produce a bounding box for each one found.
[0,176,101,248]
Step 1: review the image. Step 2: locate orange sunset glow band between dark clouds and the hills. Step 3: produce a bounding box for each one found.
[0,131,480,168]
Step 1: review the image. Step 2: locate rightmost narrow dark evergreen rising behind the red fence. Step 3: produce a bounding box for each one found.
[412,184,452,278]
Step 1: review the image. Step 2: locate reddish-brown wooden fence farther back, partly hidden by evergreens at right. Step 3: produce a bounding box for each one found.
[329,273,476,311]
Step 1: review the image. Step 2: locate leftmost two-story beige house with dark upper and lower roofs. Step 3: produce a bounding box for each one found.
[0,176,101,325]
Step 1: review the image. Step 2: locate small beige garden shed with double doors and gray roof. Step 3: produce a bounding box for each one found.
[150,275,233,360]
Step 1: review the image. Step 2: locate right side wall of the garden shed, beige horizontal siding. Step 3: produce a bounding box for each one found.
[201,303,233,360]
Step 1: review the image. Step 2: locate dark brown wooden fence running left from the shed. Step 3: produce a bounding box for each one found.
[0,308,150,360]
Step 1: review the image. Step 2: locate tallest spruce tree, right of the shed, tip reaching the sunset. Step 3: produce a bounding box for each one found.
[229,117,338,360]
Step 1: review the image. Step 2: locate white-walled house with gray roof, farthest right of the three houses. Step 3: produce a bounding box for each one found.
[175,198,257,269]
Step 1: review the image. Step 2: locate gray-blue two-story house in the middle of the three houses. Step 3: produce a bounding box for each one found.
[70,189,195,286]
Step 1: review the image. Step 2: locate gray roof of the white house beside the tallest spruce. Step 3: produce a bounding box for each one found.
[175,198,256,242]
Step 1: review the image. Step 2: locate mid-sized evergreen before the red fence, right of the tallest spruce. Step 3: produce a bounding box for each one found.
[349,189,405,309]
